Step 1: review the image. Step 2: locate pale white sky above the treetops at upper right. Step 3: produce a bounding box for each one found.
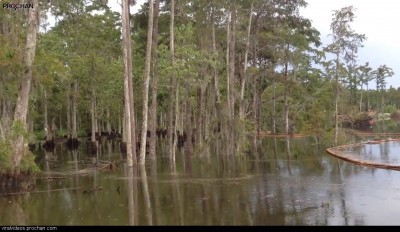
[301,0,400,88]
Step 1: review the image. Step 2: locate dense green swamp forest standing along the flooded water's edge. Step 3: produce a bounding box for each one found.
[0,0,400,174]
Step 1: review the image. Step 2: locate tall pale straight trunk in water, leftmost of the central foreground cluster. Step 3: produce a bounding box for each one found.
[121,0,136,167]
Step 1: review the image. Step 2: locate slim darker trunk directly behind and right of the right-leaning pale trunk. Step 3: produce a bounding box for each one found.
[149,0,160,159]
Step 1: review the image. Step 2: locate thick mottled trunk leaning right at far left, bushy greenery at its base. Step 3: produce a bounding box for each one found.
[12,0,39,171]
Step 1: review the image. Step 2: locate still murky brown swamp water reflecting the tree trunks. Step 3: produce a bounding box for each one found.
[0,138,400,225]
